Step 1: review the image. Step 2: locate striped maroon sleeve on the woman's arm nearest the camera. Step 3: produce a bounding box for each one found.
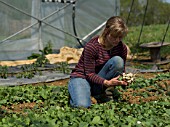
[83,43,105,85]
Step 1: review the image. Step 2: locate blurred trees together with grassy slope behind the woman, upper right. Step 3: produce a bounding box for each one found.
[120,0,170,57]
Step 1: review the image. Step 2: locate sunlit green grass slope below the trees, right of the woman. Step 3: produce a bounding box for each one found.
[124,24,170,56]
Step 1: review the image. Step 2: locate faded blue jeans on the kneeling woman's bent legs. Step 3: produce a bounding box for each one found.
[68,56,124,108]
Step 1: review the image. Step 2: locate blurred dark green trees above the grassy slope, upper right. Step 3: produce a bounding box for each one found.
[120,0,170,26]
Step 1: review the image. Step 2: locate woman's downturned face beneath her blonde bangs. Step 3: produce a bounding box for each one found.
[106,34,122,47]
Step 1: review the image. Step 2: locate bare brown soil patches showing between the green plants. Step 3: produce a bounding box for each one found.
[1,54,170,113]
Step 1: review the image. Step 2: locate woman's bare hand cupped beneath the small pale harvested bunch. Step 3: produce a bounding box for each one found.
[104,76,128,87]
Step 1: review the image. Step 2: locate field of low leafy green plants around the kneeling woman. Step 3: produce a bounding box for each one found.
[0,72,170,127]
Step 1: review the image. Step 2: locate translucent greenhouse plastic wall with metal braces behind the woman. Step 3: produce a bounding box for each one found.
[0,0,120,61]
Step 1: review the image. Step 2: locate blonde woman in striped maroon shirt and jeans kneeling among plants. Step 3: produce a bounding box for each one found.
[68,16,128,108]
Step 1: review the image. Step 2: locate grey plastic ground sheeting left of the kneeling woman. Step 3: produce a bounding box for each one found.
[0,64,75,86]
